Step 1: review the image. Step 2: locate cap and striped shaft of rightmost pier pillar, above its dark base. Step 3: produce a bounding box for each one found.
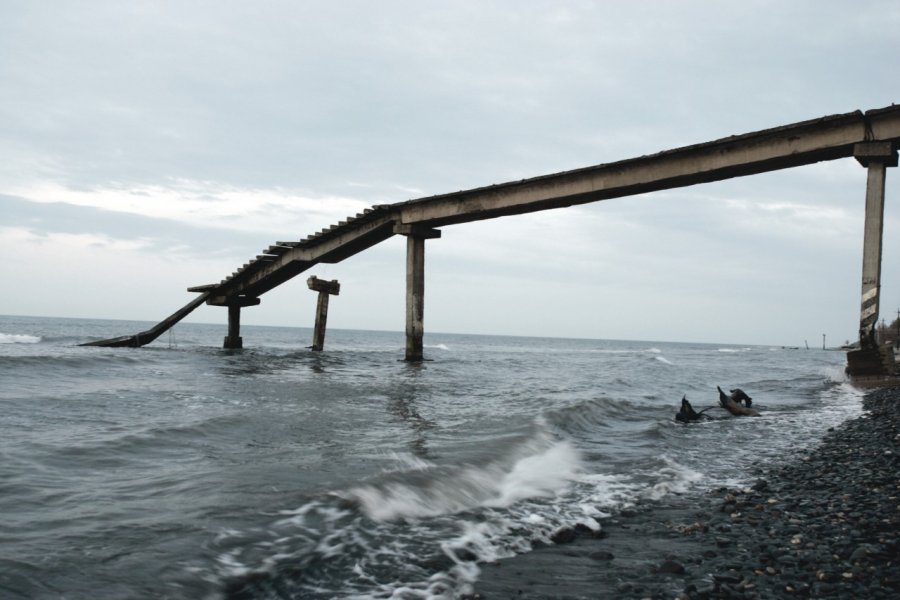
[854,142,897,348]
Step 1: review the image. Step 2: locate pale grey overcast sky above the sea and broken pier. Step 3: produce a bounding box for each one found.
[0,0,900,346]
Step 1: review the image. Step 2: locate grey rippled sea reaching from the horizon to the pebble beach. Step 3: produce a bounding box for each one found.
[0,317,861,599]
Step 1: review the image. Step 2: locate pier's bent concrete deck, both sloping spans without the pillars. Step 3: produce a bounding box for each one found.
[212,106,900,304]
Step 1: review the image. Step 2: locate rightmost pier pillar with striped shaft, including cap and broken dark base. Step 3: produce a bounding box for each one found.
[847,142,897,376]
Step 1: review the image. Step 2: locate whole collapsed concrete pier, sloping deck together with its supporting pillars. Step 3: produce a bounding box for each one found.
[81,105,900,376]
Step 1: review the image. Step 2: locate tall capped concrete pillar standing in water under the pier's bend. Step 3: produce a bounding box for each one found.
[394,224,441,362]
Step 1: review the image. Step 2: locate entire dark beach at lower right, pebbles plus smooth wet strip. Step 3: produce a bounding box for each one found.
[469,388,900,600]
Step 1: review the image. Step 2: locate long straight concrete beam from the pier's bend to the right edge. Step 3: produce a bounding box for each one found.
[393,106,900,227]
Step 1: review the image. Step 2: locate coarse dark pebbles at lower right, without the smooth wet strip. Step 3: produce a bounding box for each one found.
[682,389,900,599]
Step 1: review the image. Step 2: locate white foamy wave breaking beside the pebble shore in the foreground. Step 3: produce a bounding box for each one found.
[207,430,603,600]
